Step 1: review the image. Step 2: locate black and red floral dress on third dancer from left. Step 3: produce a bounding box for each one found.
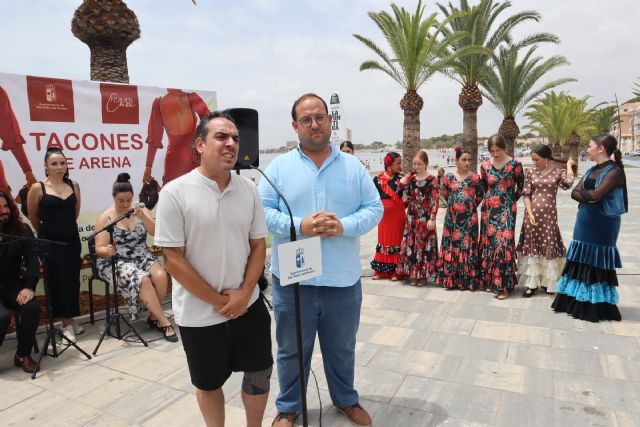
[436,173,484,290]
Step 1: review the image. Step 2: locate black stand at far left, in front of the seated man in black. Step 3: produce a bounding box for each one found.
[0,233,91,380]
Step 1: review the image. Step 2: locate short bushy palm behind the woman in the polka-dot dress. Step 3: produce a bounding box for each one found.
[525,91,593,162]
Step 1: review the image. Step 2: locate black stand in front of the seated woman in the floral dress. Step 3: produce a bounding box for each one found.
[89,209,149,356]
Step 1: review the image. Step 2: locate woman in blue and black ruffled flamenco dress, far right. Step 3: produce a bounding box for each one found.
[551,134,628,322]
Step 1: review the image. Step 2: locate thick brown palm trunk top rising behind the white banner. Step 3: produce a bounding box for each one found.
[71,0,140,83]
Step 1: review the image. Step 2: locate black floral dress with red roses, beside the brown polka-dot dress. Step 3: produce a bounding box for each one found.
[480,159,524,292]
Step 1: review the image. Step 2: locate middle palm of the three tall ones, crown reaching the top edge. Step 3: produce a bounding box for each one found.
[438,0,541,170]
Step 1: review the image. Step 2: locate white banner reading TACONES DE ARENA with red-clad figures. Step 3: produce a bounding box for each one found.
[0,73,217,249]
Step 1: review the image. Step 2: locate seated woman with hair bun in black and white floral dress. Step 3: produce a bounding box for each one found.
[96,173,178,342]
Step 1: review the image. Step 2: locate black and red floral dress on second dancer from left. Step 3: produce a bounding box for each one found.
[396,175,440,280]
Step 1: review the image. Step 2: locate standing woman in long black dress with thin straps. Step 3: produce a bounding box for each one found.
[27,147,84,342]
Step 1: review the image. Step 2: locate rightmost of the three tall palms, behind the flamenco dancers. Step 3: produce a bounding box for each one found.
[482,42,575,156]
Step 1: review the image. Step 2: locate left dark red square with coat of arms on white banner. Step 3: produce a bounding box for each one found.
[27,76,75,122]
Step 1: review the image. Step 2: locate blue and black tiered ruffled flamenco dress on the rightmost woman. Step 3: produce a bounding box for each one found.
[551,162,622,322]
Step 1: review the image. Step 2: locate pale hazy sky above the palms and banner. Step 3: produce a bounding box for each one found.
[0,0,640,148]
